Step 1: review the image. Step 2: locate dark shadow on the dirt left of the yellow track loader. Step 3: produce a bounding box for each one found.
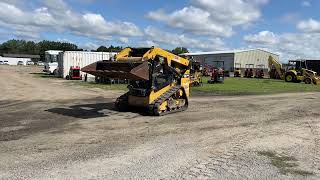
[46,102,148,119]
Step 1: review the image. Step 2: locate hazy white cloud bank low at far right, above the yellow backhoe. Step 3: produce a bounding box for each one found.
[244,31,320,62]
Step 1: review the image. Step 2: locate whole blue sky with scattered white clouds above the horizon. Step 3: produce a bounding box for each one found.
[0,0,320,61]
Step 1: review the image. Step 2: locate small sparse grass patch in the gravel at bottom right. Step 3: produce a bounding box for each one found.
[258,151,314,176]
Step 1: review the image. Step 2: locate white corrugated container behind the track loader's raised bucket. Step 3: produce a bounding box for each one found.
[58,51,117,79]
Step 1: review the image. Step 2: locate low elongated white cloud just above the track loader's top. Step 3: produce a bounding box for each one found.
[144,26,225,51]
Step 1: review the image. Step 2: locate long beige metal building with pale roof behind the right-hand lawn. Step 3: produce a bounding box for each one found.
[182,49,279,72]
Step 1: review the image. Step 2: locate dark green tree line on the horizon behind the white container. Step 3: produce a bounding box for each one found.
[0,39,189,60]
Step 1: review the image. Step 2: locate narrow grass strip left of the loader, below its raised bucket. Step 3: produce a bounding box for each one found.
[70,81,128,91]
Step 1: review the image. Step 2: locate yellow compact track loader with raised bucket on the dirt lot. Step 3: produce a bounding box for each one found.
[82,47,190,116]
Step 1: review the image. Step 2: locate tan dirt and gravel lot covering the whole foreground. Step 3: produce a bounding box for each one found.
[0,66,320,179]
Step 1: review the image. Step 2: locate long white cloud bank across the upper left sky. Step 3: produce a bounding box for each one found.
[0,0,141,40]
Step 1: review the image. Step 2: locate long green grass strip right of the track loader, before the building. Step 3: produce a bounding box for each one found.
[191,77,320,95]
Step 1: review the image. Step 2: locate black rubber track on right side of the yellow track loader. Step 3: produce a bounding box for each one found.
[149,86,188,116]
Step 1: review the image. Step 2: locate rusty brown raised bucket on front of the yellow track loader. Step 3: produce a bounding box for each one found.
[81,61,149,80]
